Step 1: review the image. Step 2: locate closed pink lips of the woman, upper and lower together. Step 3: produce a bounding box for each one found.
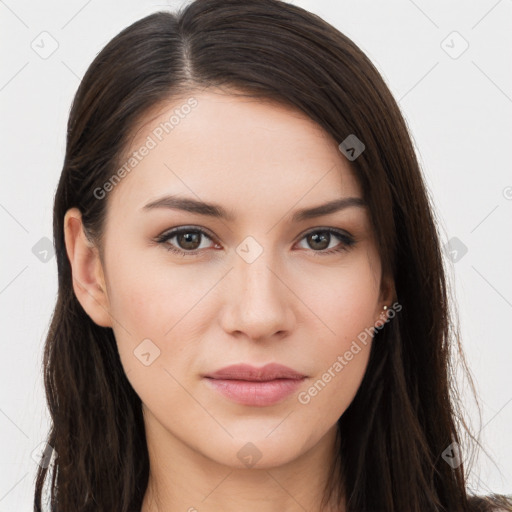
[205,363,306,406]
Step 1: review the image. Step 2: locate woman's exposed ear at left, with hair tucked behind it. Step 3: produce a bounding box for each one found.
[64,208,112,327]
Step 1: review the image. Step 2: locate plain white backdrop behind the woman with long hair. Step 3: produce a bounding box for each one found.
[0,0,512,512]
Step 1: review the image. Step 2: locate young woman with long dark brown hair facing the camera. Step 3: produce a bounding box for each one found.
[35,0,512,512]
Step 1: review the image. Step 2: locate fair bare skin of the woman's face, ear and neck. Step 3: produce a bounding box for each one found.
[65,90,393,512]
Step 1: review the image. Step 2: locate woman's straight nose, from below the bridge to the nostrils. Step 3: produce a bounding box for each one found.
[221,247,295,340]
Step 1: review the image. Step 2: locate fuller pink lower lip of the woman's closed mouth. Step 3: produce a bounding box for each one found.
[206,377,305,406]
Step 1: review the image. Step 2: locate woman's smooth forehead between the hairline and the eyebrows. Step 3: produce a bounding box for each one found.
[106,90,360,218]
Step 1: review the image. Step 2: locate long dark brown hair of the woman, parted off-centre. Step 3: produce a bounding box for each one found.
[34,0,512,512]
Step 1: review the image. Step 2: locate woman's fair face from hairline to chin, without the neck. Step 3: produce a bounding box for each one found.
[66,92,391,467]
